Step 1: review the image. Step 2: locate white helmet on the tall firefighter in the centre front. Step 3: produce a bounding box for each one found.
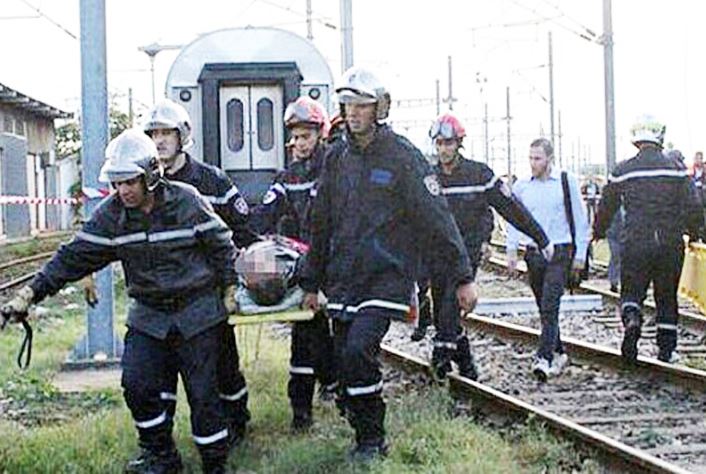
[336,67,390,120]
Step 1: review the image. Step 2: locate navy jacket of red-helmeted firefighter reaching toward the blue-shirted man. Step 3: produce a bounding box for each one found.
[437,157,549,265]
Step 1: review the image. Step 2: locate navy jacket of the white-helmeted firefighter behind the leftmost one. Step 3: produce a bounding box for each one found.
[167,153,259,248]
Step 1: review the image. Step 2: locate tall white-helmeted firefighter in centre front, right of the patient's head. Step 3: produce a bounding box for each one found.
[300,68,476,460]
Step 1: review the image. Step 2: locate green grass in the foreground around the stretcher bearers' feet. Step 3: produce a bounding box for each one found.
[0,272,599,474]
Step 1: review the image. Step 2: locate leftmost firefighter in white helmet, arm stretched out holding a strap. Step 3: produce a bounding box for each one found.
[2,129,236,473]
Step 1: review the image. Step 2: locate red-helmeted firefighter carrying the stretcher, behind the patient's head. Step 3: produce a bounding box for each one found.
[254,96,336,432]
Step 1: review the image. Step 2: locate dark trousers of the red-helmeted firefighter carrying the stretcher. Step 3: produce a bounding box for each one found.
[287,311,336,415]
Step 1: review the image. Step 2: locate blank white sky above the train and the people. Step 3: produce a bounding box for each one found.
[0,0,706,174]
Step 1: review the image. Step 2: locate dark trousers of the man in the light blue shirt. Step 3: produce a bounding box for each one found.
[525,244,571,362]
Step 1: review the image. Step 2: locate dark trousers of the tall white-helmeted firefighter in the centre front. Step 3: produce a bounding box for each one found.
[333,308,390,445]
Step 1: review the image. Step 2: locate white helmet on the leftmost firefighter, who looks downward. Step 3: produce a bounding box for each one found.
[98,128,163,191]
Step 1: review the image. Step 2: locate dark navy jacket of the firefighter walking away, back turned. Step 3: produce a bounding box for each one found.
[593,148,703,245]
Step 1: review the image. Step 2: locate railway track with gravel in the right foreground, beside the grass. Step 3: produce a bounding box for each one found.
[383,316,706,473]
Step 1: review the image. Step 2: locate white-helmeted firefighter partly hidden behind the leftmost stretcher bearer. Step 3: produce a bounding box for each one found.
[143,99,254,441]
